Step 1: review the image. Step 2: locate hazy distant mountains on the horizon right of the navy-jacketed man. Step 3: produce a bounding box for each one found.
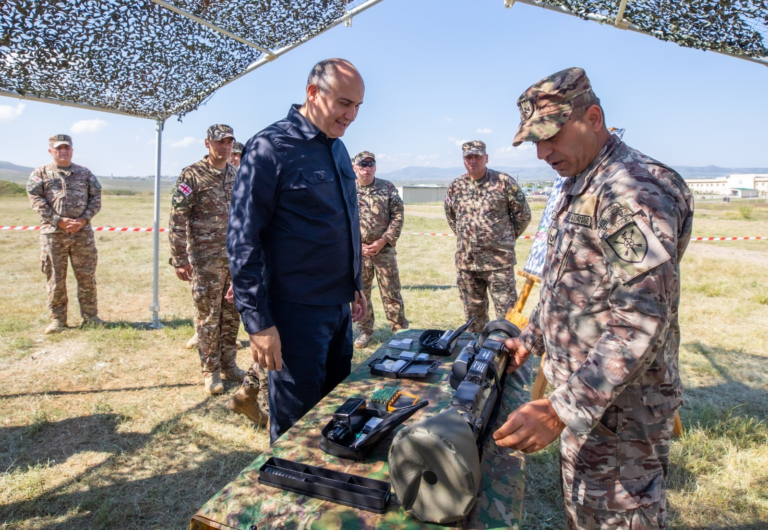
[379,165,768,184]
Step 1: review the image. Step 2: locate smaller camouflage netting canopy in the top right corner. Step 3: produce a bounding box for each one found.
[505,0,768,66]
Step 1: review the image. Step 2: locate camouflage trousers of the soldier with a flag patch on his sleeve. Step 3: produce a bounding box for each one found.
[192,260,240,372]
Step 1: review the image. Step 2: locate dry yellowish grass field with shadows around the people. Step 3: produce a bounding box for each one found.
[0,193,768,529]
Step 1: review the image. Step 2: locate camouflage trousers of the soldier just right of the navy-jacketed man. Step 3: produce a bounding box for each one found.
[357,245,408,333]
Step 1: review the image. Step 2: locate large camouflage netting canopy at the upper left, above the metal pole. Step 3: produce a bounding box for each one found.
[0,0,370,120]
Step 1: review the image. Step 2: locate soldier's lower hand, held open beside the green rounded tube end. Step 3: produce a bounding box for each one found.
[493,399,565,453]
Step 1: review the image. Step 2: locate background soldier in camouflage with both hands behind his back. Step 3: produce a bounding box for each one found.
[445,141,531,332]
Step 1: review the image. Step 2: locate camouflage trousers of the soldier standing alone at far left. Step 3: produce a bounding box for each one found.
[40,227,98,320]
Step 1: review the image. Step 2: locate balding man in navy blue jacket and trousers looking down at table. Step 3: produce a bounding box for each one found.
[227,59,366,442]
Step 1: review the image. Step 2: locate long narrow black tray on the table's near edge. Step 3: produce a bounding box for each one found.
[259,457,390,513]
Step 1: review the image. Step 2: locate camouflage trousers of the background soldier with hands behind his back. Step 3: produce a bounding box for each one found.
[456,267,517,333]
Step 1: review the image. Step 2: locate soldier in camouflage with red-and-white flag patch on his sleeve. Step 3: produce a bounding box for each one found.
[169,125,245,394]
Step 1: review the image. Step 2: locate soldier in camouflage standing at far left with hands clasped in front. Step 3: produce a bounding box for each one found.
[27,134,104,335]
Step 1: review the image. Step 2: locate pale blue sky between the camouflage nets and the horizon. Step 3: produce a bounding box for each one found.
[0,0,768,176]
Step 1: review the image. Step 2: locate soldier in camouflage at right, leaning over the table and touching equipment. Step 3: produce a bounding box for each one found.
[494,68,693,530]
